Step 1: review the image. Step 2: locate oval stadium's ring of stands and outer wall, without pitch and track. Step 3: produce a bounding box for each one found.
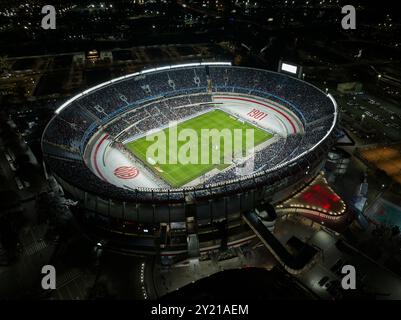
[42,62,337,255]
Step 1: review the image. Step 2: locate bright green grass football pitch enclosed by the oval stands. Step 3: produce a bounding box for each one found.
[125,110,273,188]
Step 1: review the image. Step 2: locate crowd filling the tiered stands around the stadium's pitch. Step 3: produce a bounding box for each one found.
[43,66,334,196]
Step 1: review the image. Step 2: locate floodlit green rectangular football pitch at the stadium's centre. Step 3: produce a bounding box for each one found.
[126,109,273,187]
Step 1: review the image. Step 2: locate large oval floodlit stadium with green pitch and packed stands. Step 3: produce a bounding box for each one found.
[42,62,337,256]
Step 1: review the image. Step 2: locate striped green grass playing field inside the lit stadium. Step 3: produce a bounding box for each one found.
[125,110,272,188]
